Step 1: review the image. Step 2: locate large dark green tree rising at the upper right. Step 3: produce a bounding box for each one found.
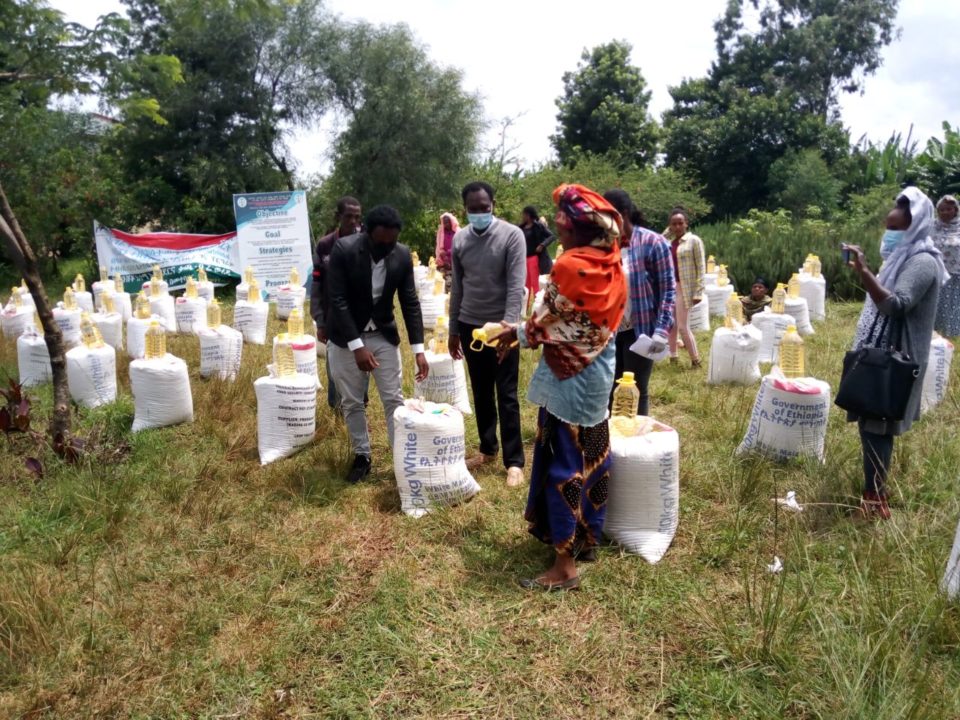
[664,0,898,214]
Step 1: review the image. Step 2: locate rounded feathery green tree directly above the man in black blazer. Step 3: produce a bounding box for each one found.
[325,23,483,216]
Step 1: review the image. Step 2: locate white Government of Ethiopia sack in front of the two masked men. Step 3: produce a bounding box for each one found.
[393,400,480,517]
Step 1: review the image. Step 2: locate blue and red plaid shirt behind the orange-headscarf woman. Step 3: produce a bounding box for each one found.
[624,226,676,337]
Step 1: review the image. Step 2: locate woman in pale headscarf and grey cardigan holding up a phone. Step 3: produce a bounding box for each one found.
[843,187,949,520]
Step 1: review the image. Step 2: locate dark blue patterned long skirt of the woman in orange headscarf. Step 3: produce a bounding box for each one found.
[524,408,610,555]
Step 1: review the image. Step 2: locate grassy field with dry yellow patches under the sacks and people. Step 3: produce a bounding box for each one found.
[0,296,960,718]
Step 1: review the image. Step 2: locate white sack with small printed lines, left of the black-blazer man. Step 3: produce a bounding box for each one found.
[253,373,317,465]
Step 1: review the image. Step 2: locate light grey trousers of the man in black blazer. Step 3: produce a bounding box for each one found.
[327,332,403,457]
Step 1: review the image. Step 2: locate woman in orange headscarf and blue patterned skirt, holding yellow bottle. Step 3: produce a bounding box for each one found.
[498,185,627,590]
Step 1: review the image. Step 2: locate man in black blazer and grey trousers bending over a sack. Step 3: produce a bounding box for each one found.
[327,205,429,483]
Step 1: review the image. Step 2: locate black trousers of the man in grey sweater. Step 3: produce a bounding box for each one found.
[459,322,523,468]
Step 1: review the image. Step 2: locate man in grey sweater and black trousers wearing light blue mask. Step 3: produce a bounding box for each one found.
[449,182,527,486]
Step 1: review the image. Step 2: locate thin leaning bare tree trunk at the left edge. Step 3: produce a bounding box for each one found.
[0,184,70,438]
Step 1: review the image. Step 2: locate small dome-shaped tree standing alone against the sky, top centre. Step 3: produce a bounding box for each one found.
[551,40,658,167]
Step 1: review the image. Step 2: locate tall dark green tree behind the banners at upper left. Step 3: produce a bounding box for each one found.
[113,0,336,232]
